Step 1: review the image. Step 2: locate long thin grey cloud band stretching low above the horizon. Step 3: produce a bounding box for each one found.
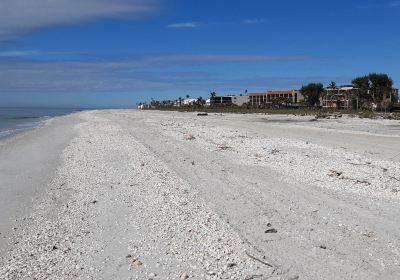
[0,54,312,92]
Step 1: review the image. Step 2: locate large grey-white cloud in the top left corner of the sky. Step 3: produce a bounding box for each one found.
[0,0,160,40]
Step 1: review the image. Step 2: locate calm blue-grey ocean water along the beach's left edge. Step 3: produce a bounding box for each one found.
[0,107,83,138]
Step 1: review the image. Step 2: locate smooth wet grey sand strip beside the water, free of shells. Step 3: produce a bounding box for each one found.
[0,113,84,253]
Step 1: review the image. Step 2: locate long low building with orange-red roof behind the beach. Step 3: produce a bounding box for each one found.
[248,90,304,106]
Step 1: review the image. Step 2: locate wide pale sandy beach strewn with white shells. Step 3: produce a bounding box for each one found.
[0,110,400,280]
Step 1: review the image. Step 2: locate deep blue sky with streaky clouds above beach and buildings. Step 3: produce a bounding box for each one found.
[0,0,400,107]
